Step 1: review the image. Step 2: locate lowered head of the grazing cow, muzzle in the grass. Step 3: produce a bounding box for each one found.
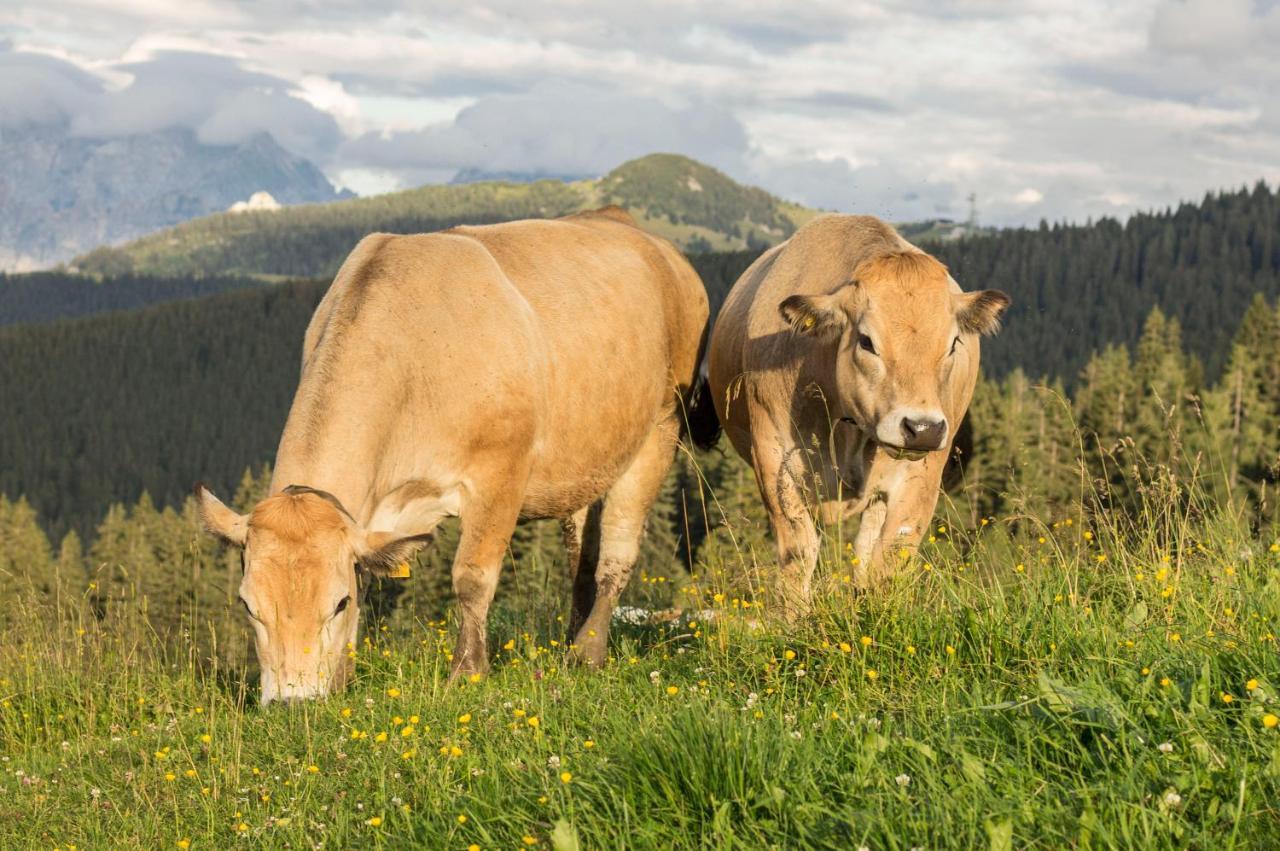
[196,485,430,704]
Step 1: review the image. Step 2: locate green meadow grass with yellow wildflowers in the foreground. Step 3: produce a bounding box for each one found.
[0,493,1280,850]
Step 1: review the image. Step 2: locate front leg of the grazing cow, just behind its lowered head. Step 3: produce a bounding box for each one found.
[449,479,524,681]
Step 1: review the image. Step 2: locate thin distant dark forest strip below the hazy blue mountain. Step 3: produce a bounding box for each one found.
[0,271,262,325]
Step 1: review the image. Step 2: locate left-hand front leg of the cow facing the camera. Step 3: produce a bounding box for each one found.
[751,436,818,621]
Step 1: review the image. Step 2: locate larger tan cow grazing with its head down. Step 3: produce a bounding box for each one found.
[197,209,708,703]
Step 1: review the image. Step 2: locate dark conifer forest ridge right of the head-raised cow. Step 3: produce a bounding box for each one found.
[929,183,1280,383]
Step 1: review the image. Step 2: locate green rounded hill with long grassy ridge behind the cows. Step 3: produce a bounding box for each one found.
[74,154,817,276]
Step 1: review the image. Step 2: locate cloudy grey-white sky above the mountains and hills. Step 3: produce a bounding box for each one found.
[0,0,1280,224]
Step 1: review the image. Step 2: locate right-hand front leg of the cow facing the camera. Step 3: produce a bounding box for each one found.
[854,458,945,589]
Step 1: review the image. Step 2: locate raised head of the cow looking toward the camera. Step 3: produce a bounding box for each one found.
[780,252,1010,458]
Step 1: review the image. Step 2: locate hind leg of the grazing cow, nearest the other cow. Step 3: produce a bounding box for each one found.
[571,418,678,668]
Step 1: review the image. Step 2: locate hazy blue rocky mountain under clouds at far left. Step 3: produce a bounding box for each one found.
[0,124,340,270]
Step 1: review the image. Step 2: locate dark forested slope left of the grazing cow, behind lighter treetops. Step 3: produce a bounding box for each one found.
[0,283,324,535]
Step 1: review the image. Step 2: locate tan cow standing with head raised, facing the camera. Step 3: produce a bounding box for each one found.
[709,215,1009,616]
